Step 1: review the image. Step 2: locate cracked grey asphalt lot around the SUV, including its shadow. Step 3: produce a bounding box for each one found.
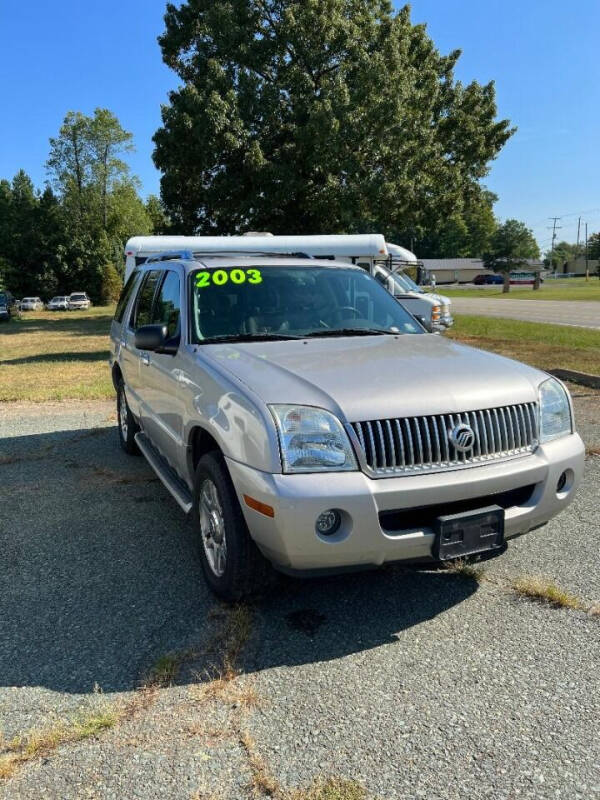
[0,396,600,800]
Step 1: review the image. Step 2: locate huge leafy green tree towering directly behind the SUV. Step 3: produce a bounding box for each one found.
[153,0,512,238]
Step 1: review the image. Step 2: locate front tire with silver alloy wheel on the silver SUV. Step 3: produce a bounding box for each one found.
[192,453,272,602]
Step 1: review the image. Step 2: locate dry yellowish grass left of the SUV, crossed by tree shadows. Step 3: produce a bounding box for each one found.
[0,306,114,402]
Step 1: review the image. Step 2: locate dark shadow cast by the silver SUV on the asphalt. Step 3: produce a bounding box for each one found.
[0,428,477,693]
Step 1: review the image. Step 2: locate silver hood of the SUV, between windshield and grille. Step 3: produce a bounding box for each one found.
[199,334,547,422]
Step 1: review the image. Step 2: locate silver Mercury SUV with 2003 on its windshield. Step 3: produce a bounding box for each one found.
[111,255,584,599]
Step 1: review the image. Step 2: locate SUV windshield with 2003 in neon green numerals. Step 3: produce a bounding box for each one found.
[190,264,423,343]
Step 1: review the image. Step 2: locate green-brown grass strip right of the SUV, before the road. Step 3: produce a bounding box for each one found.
[447,314,600,375]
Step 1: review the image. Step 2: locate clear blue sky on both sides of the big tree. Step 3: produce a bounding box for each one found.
[0,0,600,249]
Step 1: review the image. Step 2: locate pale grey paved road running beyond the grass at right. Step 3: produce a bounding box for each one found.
[450,296,600,329]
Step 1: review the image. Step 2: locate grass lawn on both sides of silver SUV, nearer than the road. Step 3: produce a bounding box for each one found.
[0,307,600,402]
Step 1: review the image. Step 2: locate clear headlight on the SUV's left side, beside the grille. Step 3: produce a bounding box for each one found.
[270,405,358,472]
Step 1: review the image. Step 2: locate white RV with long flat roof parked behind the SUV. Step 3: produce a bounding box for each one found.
[125,233,453,331]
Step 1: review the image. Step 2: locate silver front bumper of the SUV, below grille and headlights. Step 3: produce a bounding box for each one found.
[227,434,584,571]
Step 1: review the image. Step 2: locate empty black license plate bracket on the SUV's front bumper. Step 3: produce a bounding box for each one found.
[433,506,504,561]
